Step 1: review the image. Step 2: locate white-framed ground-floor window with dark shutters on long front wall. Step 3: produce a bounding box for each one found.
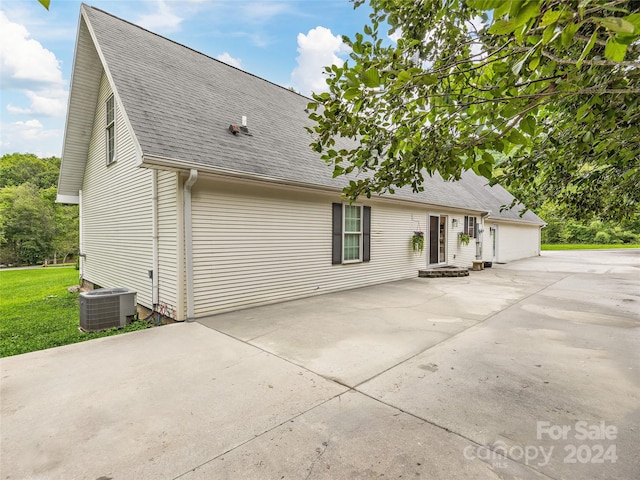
[332,203,371,264]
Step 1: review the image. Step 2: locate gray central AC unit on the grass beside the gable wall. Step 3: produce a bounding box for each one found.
[80,288,137,332]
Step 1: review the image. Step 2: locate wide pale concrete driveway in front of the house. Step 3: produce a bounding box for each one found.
[0,250,640,480]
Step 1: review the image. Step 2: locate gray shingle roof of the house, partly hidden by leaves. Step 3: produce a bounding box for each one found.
[83,5,542,223]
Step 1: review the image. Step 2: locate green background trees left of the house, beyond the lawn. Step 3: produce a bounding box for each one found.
[0,153,79,265]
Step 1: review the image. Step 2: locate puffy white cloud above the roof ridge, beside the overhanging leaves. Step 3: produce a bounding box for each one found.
[291,26,349,95]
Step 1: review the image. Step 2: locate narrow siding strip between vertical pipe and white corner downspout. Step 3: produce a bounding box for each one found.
[158,171,185,320]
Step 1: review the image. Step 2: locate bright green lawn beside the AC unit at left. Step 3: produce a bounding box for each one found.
[0,267,150,357]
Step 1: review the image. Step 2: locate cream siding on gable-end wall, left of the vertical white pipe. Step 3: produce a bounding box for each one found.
[82,74,153,307]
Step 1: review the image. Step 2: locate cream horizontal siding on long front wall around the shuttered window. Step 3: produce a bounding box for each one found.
[193,176,426,317]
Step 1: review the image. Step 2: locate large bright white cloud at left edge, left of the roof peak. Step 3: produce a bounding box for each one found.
[0,11,65,89]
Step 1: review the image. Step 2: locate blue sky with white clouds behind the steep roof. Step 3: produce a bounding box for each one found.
[0,0,368,156]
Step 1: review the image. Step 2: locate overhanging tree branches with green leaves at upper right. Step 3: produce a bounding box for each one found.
[309,0,640,219]
